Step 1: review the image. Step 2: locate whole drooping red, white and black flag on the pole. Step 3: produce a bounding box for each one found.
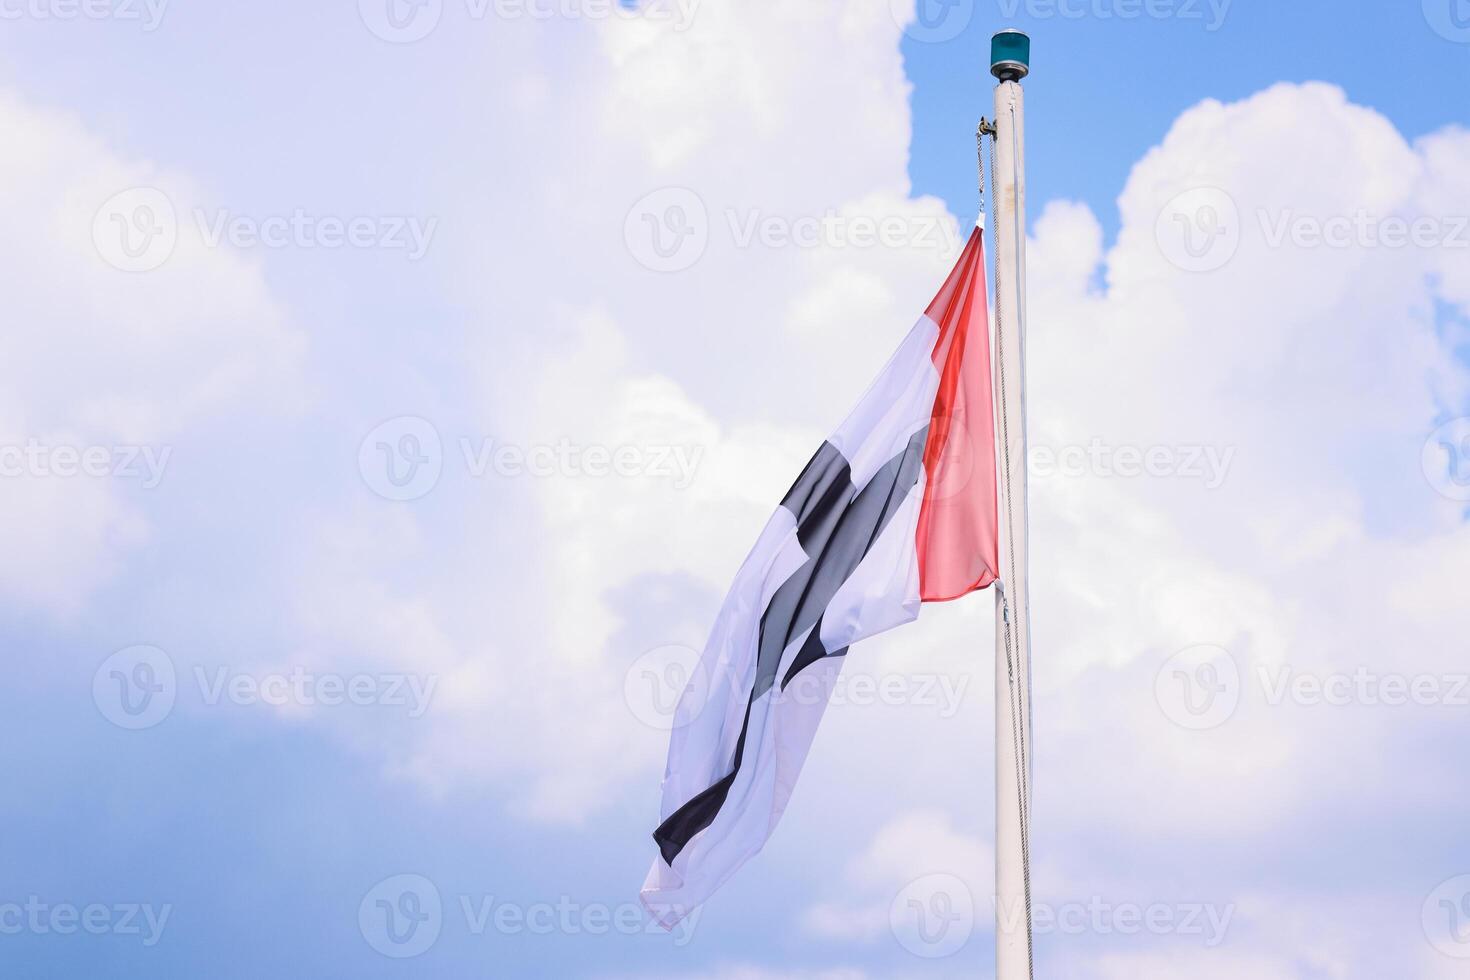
[642,229,997,929]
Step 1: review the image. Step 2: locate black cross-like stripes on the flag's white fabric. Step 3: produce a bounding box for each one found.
[653,426,929,865]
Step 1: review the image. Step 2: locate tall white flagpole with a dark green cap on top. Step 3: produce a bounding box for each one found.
[991,31,1033,980]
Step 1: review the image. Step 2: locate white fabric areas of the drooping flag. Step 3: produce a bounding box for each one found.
[642,316,939,929]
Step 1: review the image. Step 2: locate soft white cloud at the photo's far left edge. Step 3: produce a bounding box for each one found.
[0,91,301,613]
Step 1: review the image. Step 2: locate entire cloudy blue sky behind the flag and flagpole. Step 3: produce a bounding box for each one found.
[0,0,1470,980]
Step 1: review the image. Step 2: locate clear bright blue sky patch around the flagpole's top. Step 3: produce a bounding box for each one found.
[904,0,1467,242]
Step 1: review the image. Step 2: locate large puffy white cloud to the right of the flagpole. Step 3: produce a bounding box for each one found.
[819,78,1470,977]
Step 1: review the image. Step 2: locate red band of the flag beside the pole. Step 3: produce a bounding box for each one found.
[917,229,1000,602]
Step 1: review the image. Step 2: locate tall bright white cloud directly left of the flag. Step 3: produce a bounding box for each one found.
[276,3,967,821]
